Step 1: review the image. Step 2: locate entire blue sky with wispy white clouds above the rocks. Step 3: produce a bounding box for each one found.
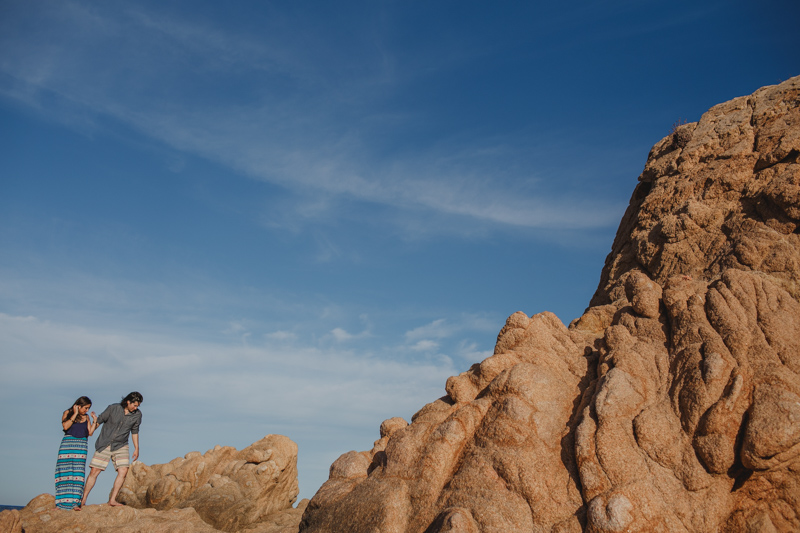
[0,0,800,505]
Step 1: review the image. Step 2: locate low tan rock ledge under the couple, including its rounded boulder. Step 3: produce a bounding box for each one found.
[0,435,308,533]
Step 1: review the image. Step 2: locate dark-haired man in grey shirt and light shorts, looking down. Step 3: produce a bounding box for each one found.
[81,392,143,506]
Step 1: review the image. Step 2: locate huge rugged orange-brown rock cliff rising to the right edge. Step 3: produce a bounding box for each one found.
[300,78,800,533]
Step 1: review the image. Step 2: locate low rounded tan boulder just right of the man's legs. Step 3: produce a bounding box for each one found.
[119,435,298,531]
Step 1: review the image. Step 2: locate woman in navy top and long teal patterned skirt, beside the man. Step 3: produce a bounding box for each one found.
[56,396,97,511]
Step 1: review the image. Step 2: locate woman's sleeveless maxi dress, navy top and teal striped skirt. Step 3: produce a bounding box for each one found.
[56,419,89,510]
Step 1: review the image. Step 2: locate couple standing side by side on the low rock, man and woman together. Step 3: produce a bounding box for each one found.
[56,392,143,511]
